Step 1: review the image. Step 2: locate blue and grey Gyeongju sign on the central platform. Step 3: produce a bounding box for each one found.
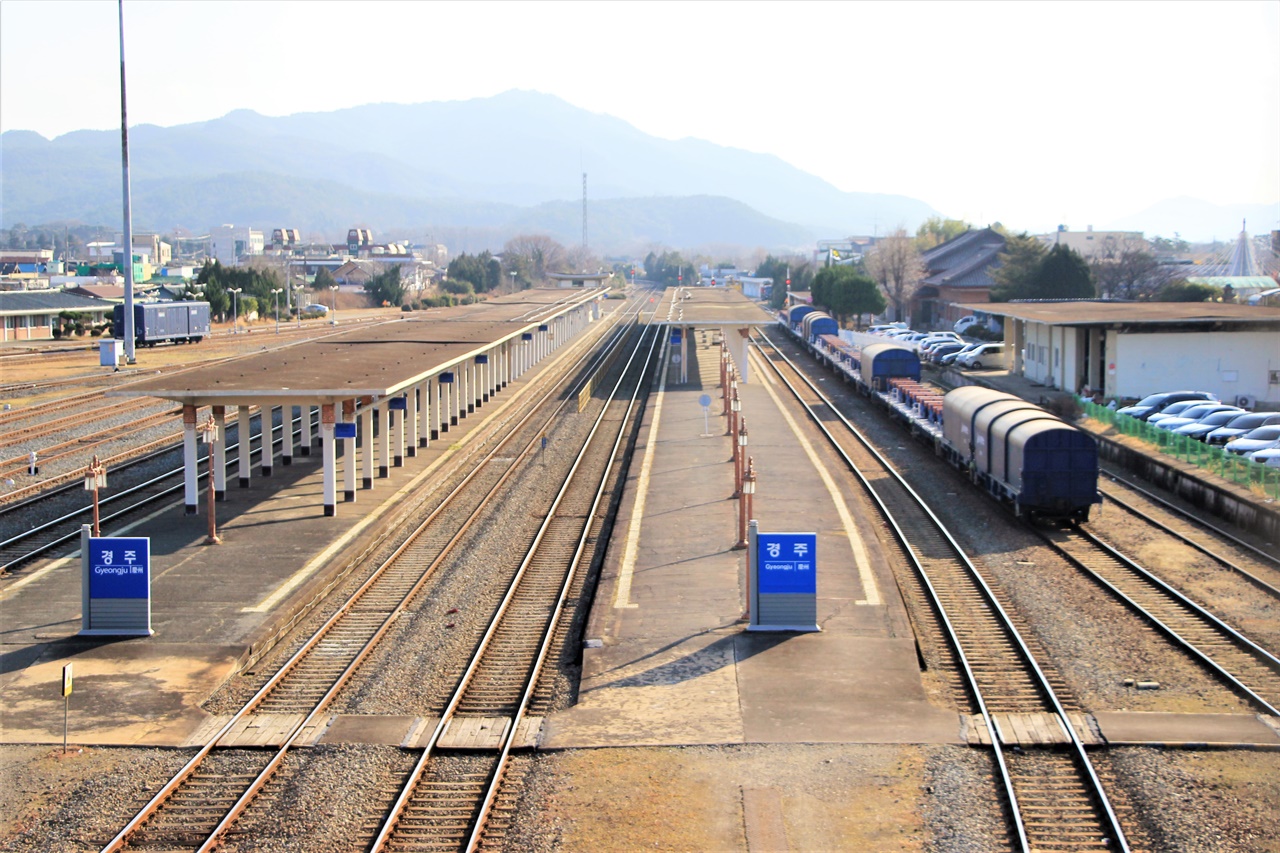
[746,521,822,631]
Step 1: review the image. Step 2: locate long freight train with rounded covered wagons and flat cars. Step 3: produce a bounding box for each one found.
[778,306,1102,523]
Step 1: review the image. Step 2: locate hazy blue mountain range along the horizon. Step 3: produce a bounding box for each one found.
[0,91,936,252]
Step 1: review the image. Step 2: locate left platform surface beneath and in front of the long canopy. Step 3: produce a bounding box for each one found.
[0,311,604,747]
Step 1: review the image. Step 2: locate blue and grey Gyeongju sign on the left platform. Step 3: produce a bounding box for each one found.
[81,524,155,637]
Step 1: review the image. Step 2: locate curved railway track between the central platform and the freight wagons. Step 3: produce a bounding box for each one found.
[754,334,1129,852]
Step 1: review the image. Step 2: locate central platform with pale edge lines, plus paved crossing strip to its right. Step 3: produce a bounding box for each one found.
[539,330,1280,749]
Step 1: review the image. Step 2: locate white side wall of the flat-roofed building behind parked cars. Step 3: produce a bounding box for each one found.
[1107,332,1280,403]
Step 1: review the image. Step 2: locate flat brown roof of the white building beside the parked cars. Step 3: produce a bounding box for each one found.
[982,300,1280,329]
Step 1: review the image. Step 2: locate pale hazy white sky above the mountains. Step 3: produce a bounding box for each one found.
[0,0,1280,231]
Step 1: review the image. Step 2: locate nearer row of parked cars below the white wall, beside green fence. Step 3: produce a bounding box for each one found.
[1116,391,1280,467]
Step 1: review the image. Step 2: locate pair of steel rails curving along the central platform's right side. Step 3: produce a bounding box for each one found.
[756,332,1129,853]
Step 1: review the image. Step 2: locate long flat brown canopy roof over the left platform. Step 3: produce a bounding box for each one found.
[108,288,607,406]
